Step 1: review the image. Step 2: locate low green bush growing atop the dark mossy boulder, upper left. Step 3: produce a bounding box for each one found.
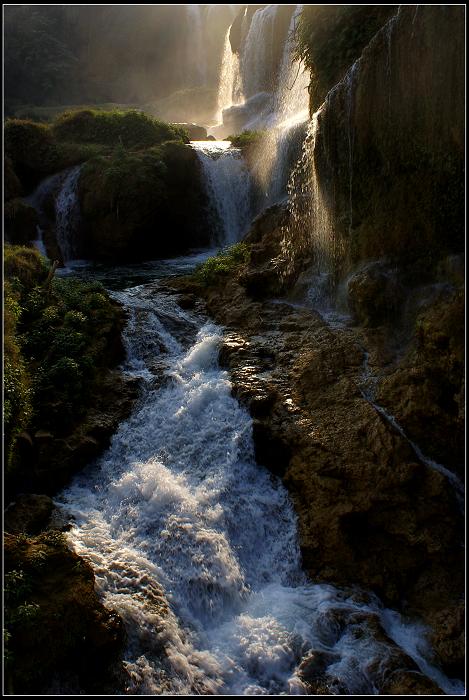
[51,109,185,149]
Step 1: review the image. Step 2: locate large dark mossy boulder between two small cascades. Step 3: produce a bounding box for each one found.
[79,141,211,261]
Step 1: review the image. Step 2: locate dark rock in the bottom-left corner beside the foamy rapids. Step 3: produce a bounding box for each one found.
[4,495,126,695]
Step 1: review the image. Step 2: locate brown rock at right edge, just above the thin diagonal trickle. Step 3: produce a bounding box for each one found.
[377,291,464,477]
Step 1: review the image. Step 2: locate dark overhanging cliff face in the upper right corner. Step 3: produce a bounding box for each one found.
[315,6,464,274]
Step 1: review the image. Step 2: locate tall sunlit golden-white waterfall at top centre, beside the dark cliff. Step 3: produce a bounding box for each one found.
[213,5,309,210]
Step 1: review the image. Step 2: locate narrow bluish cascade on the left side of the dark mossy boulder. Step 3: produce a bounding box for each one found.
[55,165,81,263]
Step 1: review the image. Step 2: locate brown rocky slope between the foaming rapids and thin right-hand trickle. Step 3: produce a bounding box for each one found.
[173,270,464,693]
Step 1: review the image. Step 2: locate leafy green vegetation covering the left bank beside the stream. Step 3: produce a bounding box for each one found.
[4,245,123,490]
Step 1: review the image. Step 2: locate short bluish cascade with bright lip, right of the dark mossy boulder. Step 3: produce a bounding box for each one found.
[192,141,251,246]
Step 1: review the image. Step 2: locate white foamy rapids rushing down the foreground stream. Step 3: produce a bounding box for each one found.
[56,284,461,695]
